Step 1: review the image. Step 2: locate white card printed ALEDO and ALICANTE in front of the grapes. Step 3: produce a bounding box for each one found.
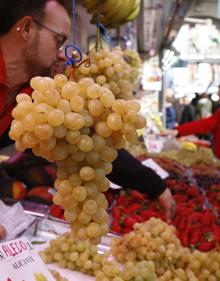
[0,237,55,281]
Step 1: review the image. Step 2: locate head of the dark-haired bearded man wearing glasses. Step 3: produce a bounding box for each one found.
[0,0,70,78]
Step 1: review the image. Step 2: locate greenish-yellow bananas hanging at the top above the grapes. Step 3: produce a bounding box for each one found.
[82,0,141,27]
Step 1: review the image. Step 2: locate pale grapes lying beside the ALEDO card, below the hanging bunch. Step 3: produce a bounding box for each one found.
[40,230,157,281]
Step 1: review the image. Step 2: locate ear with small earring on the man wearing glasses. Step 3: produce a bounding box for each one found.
[16,16,36,40]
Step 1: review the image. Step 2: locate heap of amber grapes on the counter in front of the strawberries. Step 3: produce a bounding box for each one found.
[111,218,220,281]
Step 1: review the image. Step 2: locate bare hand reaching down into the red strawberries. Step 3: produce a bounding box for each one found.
[159,188,176,223]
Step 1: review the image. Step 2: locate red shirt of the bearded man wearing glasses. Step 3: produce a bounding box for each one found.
[0,48,32,138]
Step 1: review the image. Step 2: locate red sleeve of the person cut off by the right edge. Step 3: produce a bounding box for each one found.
[176,109,220,158]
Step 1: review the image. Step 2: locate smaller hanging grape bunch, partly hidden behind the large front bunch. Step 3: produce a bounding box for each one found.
[72,49,133,100]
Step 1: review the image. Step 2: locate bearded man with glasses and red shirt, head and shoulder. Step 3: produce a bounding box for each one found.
[0,0,71,145]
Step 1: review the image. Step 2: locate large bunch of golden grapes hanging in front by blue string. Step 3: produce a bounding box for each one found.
[9,74,145,244]
